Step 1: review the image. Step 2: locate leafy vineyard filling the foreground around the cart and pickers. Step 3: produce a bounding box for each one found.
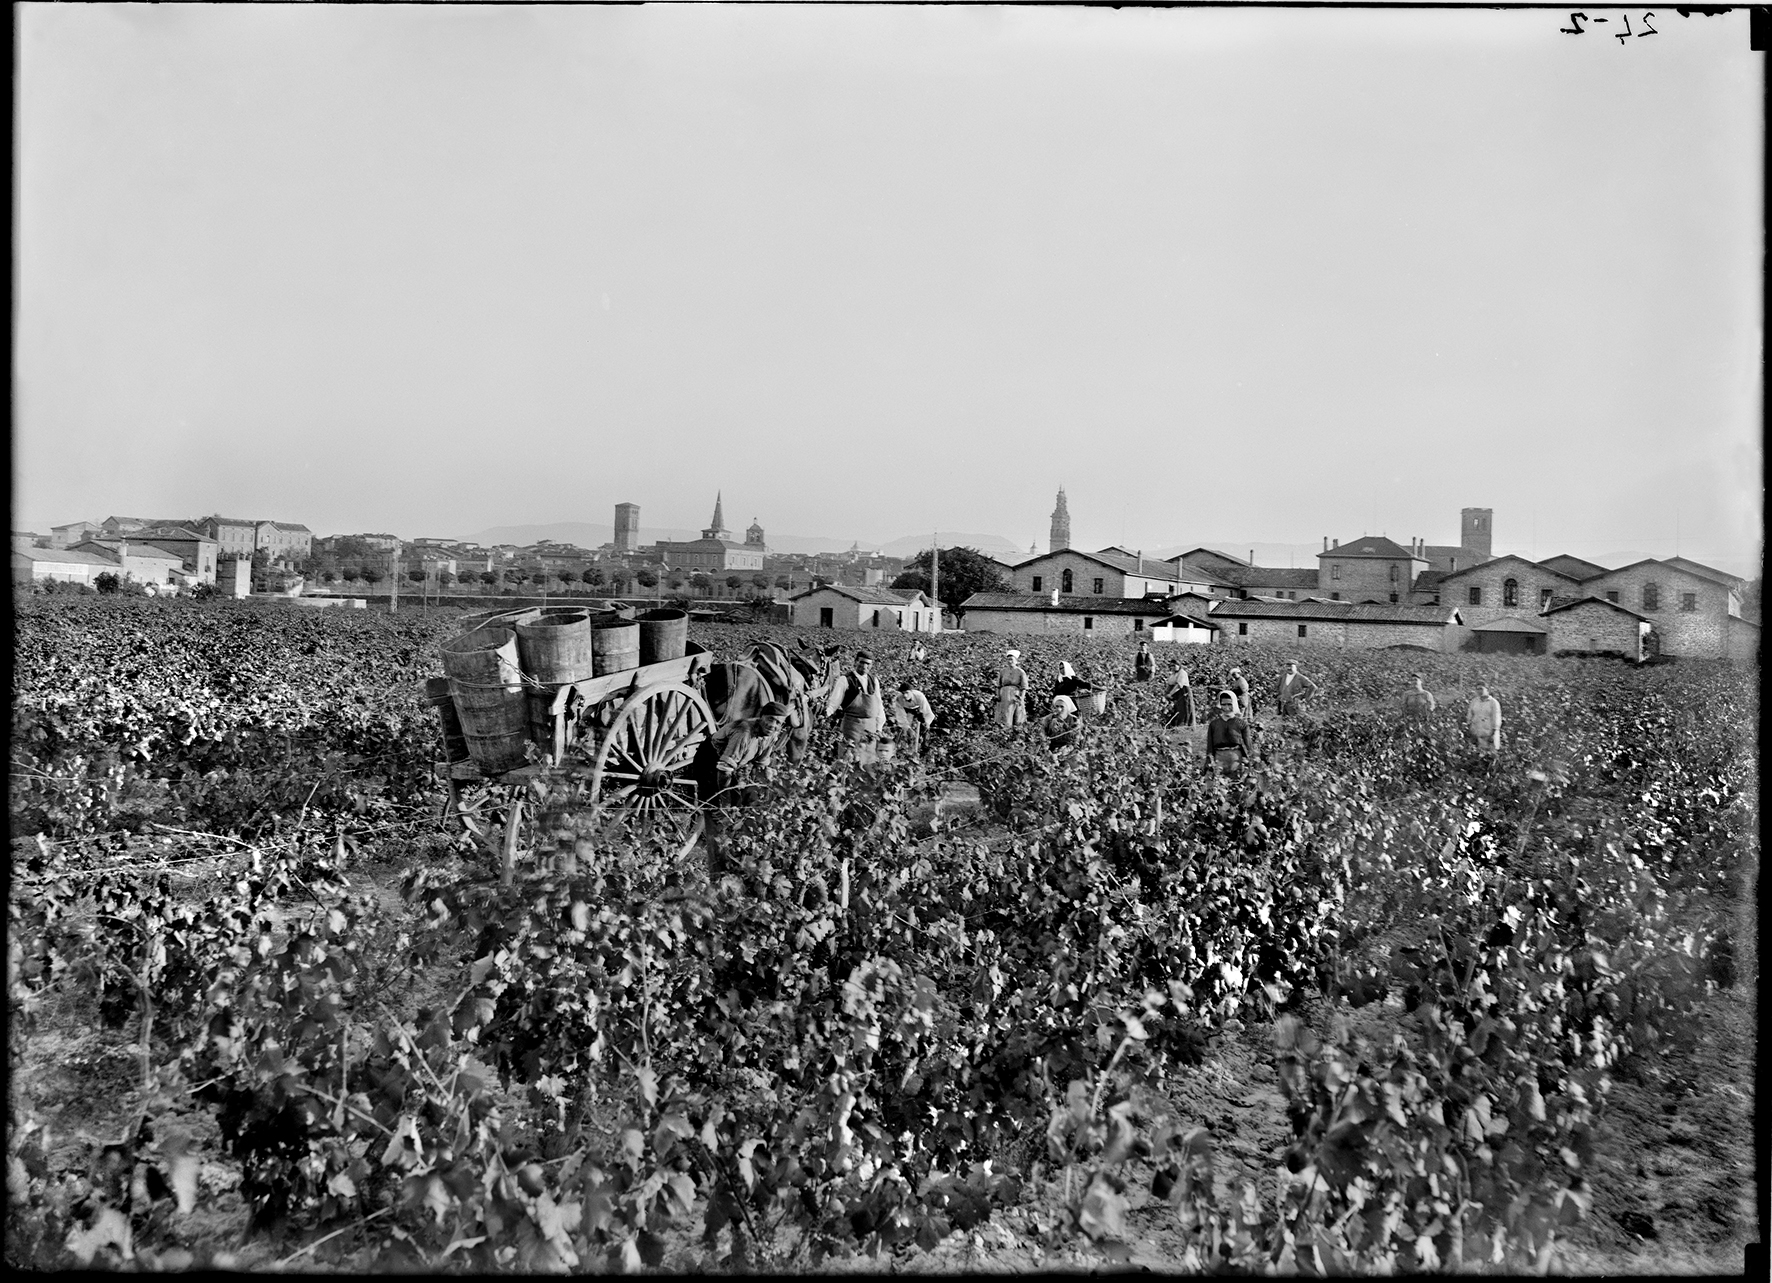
[5,597,1761,1272]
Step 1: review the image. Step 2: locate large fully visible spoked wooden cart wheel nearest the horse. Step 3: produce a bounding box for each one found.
[590,682,714,856]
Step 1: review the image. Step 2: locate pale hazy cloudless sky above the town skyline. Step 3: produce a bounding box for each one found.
[14,5,1765,572]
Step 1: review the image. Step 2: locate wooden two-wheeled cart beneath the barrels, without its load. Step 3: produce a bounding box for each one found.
[438,642,714,884]
